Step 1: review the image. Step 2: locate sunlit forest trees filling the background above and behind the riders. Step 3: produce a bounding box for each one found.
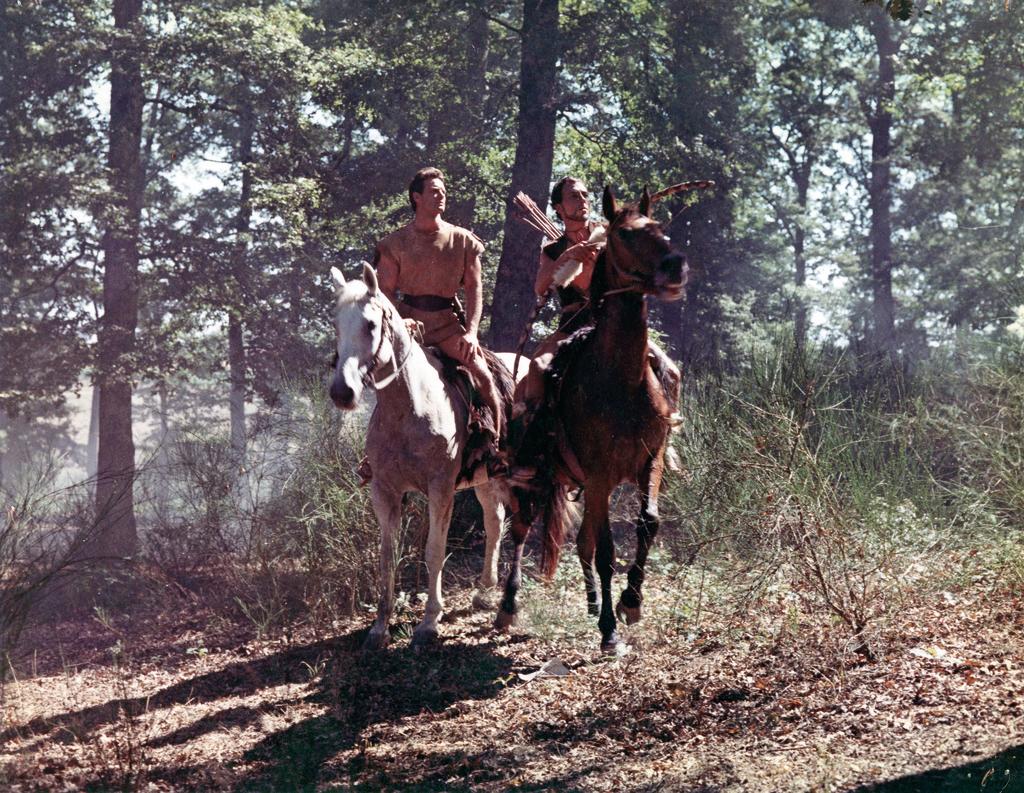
[0,0,1024,549]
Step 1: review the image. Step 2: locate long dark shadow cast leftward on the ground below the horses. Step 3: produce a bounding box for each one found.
[7,629,511,791]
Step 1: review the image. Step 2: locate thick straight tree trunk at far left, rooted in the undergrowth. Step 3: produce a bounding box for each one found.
[90,0,143,557]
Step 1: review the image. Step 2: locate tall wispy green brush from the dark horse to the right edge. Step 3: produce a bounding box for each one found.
[662,339,1024,658]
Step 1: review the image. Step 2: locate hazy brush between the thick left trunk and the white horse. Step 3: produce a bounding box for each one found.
[136,378,415,633]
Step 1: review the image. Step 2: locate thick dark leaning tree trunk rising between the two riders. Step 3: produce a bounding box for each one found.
[489,0,561,350]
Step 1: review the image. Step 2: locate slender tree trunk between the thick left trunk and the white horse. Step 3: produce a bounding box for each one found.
[227,100,253,473]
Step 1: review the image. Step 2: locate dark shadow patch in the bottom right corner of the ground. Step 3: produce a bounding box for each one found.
[852,746,1024,793]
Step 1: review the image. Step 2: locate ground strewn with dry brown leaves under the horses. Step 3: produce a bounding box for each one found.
[0,562,1024,792]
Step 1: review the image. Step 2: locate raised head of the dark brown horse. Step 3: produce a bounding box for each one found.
[602,186,688,300]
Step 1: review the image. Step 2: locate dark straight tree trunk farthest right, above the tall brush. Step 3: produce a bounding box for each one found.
[868,10,896,362]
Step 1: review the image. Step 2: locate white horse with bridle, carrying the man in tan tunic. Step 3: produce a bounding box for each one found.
[331,264,520,650]
